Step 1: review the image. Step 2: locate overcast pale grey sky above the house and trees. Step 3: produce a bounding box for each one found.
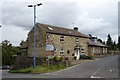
[0,0,119,45]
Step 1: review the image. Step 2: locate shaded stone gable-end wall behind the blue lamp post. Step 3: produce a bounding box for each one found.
[28,26,46,57]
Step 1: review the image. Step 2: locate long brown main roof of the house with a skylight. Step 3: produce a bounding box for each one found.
[36,23,89,38]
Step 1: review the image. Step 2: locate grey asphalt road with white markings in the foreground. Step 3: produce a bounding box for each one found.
[2,55,120,78]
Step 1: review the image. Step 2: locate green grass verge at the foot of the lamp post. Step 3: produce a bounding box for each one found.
[9,64,66,73]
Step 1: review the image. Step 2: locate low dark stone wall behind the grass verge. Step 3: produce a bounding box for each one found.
[13,55,71,70]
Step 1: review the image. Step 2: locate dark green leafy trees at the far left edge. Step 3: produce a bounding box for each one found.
[1,40,20,65]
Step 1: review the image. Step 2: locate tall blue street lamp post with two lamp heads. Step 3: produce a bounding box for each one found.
[28,3,42,69]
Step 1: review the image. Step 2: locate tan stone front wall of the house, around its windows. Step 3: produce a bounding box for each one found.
[46,34,88,59]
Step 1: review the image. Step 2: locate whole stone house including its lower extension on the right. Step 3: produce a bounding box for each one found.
[21,23,107,60]
